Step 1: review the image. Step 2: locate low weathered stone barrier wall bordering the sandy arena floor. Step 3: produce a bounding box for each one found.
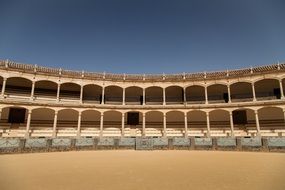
[0,137,285,154]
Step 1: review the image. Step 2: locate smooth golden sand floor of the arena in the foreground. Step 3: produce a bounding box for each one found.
[0,150,285,190]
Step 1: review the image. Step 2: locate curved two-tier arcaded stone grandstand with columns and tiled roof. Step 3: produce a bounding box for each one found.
[0,61,285,138]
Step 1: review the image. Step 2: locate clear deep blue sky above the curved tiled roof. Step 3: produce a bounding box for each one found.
[0,0,285,73]
